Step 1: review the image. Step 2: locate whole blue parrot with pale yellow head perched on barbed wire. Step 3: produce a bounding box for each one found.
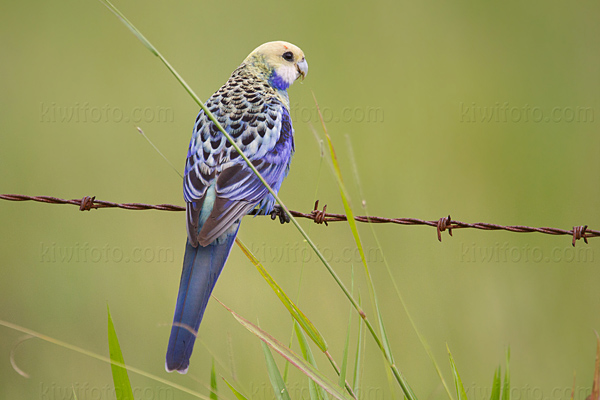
[165,41,308,374]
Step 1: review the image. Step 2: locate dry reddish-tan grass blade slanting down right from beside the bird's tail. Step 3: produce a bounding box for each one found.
[215,298,352,400]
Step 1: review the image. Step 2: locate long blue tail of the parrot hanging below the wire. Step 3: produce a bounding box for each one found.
[165,230,237,374]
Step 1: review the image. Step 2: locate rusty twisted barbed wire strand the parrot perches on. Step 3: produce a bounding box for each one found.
[0,194,600,246]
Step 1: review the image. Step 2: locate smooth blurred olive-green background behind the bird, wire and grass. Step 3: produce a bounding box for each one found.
[0,0,600,400]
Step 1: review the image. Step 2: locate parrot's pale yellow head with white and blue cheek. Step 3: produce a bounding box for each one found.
[244,41,308,90]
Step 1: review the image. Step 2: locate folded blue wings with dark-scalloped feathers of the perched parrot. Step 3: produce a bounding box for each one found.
[184,98,294,246]
